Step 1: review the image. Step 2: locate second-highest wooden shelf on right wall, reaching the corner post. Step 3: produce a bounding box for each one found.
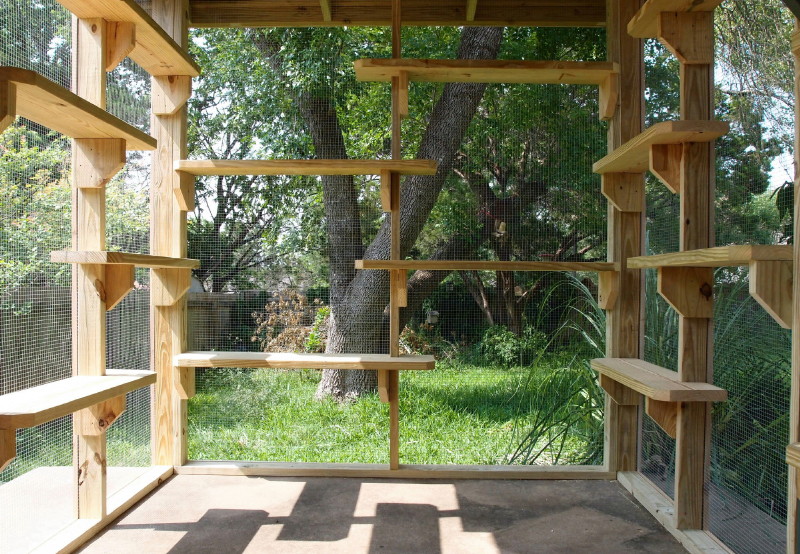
[592,120,730,173]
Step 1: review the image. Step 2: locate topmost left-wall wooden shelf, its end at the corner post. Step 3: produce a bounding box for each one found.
[58,0,200,77]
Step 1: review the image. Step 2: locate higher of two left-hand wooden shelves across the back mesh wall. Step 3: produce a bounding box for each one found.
[175,160,438,176]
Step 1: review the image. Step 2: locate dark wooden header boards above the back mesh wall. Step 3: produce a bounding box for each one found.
[190,0,605,27]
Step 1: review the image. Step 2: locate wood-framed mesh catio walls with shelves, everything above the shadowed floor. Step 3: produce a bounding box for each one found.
[0,0,800,552]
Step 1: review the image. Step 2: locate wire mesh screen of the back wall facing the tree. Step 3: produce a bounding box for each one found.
[189,28,606,464]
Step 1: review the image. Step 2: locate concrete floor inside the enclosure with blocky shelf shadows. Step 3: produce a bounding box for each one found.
[81,475,685,554]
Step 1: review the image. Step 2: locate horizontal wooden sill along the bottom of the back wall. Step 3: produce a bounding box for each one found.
[175,461,615,480]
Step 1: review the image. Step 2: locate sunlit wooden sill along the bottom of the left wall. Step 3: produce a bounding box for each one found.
[31,466,174,554]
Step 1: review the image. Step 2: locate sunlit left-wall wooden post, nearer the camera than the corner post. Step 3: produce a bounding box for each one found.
[72,19,106,519]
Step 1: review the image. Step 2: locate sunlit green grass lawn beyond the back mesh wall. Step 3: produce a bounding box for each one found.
[189,356,600,464]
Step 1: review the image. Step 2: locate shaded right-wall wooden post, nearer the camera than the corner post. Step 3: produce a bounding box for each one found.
[675,14,714,529]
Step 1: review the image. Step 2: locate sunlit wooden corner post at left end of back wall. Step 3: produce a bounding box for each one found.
[150,0,192,465]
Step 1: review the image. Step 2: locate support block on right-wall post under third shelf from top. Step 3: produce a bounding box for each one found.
[658,267,714,318]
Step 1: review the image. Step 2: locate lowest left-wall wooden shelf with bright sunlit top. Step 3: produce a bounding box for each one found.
[0,369,156,429]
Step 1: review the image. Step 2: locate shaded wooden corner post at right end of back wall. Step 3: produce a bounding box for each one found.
[604,0,644,471]
